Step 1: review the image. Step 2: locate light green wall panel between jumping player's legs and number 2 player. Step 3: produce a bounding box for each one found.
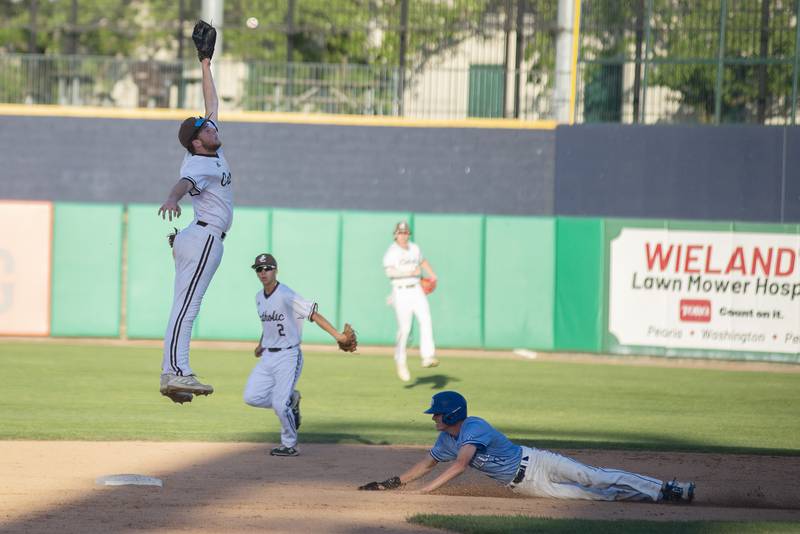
[195,207,271,347]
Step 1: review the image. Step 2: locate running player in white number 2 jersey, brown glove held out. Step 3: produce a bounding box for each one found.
[244,253,358,456]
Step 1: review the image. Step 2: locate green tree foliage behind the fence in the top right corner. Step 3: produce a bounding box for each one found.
[653,0,796,122]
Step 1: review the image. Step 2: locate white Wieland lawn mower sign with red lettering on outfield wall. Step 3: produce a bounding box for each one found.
[608,228,800,354]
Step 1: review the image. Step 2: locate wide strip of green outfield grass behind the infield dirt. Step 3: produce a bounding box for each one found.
[0,342,800,455]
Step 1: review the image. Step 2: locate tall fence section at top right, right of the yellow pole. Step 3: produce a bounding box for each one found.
[576,0,800,124]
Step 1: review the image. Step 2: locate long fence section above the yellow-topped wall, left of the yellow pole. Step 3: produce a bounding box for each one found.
[0,0,557,119]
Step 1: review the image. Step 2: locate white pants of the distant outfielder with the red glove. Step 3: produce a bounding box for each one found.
[392,284,436,364]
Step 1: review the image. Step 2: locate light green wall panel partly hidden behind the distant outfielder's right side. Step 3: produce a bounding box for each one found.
[412,214,484,347]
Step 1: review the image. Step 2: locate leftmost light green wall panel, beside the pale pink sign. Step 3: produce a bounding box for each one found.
[50,202,123,337]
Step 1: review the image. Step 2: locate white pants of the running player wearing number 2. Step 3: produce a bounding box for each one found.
[244,347,303,447]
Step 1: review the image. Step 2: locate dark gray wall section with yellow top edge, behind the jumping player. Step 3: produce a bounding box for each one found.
[0,117,555,215]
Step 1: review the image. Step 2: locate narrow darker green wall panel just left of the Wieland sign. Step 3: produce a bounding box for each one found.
[554,217,605,352]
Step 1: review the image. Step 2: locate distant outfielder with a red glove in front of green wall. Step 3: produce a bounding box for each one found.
[383,221,439,382]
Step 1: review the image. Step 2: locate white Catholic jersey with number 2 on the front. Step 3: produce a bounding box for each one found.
[256,282,317,349]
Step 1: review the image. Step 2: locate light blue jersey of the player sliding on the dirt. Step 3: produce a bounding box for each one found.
[431,417,522,484]
